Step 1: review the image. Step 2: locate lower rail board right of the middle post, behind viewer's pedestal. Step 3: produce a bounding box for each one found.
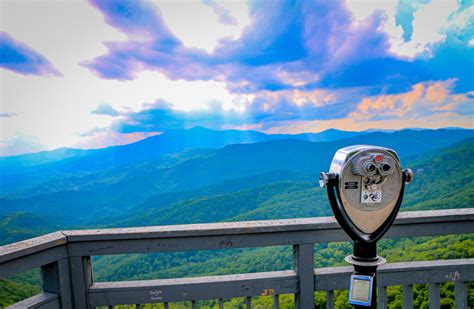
[314,259,474,291]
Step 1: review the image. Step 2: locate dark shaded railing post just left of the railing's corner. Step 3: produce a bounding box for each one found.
[41,258,72,308]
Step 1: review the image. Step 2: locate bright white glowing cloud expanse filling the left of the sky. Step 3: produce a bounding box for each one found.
[0,1,248,149]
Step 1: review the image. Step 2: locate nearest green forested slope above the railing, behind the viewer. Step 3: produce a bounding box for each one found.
[110,139,474,226]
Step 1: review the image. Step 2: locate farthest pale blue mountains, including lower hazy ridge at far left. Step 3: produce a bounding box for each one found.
[0,127,363,195]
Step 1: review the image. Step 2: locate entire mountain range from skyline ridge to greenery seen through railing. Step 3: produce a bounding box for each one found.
[0,127,474,307]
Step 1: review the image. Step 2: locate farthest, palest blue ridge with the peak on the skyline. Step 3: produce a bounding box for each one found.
[0,127,364,174]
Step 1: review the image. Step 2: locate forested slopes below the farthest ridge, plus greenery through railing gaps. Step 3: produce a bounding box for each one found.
[0,131,474,308]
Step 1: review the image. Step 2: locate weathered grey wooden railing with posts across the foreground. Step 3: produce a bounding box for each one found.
[0,208,474,309]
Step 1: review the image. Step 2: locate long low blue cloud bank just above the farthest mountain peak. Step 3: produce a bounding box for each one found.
[105,89,363,135]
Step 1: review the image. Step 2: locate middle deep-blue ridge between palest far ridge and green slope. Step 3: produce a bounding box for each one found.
[0,126,472,221]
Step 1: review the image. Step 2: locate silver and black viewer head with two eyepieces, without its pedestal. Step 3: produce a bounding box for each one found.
[320,145,413,238]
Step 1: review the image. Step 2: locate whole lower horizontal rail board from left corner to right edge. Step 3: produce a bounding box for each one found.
[89,259,474,306]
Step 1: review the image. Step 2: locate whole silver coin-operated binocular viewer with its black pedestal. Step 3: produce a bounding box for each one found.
[319,145,413,308]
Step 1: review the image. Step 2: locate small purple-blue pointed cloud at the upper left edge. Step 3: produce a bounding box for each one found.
[0,31,62,76]
